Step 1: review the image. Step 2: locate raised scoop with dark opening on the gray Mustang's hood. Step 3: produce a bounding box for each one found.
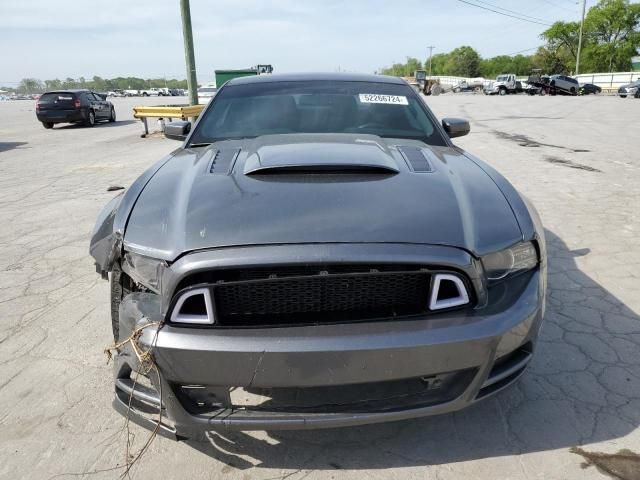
[244,140,399,175]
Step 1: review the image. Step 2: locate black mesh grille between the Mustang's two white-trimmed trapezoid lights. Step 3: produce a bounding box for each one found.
[213,269,430,326]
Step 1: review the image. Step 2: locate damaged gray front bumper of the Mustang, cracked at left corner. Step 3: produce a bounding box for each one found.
[114,264,546,439]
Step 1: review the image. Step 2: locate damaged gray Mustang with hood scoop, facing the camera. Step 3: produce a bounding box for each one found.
[90,74,546,439]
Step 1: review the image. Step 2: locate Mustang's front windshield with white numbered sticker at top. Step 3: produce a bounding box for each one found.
[190,81,446,145]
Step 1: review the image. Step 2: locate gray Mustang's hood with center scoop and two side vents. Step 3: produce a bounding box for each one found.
[124,134,522,261]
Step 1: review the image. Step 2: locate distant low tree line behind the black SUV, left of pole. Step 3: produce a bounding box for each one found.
[0,76,187,94]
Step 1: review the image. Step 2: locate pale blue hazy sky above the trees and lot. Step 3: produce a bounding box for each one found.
[0,0,595,86]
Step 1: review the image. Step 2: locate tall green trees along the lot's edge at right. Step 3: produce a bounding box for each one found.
[381,0,640,78]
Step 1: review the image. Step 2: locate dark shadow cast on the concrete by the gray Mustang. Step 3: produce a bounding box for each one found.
[182,231,640,470]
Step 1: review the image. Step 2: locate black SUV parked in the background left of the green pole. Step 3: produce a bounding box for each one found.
[36,90,116,128]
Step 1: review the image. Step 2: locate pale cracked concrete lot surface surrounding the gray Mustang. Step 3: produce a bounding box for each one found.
[0,94,640,480]
